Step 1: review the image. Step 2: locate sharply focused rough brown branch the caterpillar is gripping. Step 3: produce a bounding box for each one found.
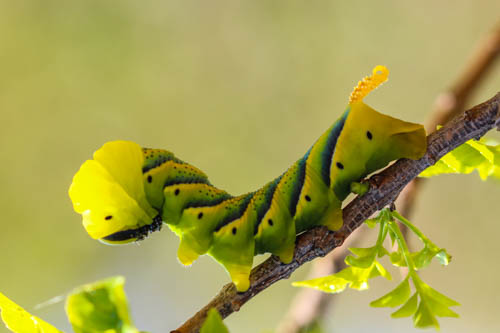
[173,92,500,333]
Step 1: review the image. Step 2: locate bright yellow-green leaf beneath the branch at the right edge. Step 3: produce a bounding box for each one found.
[420,140,500,180]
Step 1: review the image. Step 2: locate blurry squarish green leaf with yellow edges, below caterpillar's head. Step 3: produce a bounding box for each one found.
[66,276,139,333]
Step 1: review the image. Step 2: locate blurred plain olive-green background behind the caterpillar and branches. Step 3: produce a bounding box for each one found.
[0,0,500,333]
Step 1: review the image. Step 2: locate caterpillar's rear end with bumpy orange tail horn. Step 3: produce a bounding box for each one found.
[331,66,427,199]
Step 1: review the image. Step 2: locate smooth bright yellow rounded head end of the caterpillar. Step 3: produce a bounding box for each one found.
[69,141,162,244]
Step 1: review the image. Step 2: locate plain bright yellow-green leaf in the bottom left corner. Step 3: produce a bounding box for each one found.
[0,293,62,333]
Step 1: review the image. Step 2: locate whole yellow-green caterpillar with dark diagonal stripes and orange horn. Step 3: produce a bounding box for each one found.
[69,66,426,292]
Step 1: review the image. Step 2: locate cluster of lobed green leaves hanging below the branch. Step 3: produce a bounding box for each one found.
[293,209,459,329]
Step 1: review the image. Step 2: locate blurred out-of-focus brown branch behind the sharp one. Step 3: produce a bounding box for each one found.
[277,22,500,333]
